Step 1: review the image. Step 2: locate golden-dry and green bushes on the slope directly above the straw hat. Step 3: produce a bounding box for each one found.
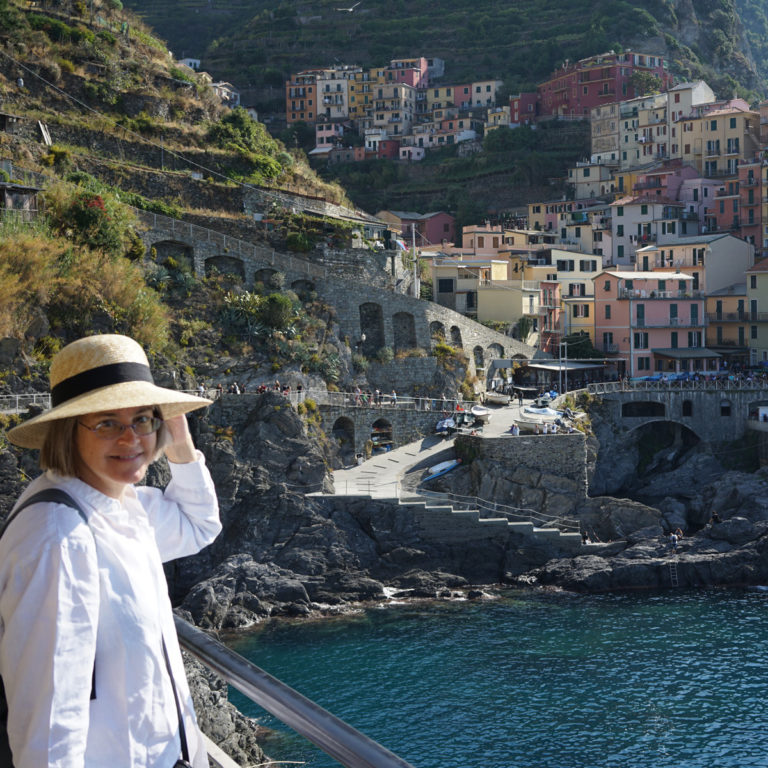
[0,186,169,352]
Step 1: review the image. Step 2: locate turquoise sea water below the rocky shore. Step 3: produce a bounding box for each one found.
[228,590,768,768]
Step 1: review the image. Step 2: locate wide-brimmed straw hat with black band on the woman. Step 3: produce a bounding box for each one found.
[8,334,211,448]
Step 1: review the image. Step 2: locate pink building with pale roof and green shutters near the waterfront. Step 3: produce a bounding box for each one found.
[595,270,720,377]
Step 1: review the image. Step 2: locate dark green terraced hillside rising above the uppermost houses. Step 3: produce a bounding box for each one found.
[126,0,768,115]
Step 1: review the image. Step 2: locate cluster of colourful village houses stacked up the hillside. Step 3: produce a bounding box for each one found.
[286,46,768,376]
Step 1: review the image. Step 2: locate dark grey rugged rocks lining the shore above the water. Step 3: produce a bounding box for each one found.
[0,392,768,763]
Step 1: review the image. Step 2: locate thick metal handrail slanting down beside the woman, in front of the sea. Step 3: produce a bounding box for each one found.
[174,616,412,768]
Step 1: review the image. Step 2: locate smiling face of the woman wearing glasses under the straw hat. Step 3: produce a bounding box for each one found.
[75,407,157,499]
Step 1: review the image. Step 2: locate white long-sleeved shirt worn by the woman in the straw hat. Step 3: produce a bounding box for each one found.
[0,454,221,768]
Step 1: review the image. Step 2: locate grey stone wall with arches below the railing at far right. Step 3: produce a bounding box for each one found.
[588,381,768,443]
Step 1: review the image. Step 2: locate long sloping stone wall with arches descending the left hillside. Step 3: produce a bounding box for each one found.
[138,211,550,378]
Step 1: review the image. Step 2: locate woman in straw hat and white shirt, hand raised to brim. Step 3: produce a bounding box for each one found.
[0,335,221,768]
